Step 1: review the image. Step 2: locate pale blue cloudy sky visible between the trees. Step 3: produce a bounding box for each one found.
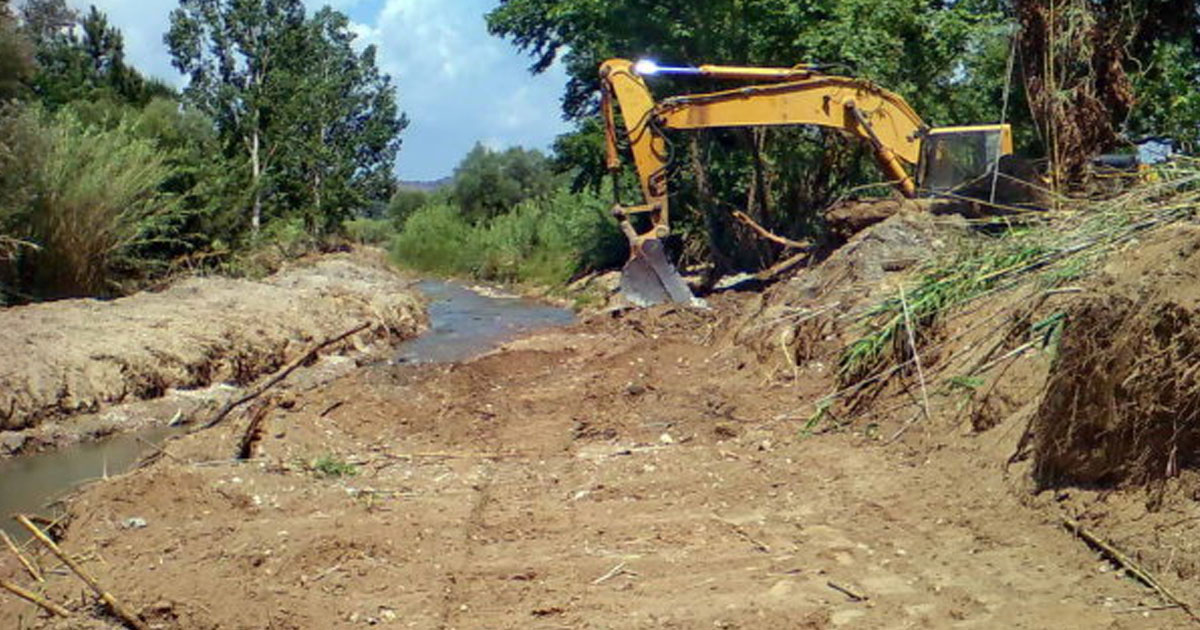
[67,0,568,180]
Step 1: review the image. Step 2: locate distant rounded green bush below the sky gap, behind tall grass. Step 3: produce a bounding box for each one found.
[451,144,554,222]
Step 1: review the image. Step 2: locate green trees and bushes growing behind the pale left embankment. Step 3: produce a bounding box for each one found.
[0,0,407,304]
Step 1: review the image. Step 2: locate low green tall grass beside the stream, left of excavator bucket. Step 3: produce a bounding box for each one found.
[391,191,624,286]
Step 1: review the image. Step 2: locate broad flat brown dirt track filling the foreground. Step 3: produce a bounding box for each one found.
[0,294,1188,630]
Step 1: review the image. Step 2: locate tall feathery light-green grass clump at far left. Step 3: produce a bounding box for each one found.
[0,109,180,296]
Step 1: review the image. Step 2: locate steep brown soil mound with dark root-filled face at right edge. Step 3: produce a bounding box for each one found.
[1032,226,1200,487]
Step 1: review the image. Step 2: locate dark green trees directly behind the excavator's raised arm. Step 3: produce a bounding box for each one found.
[487,0,1021,266]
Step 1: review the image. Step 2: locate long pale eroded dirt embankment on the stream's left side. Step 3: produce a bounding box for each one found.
[0,252,424,430]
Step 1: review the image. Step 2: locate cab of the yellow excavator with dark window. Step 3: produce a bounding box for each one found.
[917,125,1013,194]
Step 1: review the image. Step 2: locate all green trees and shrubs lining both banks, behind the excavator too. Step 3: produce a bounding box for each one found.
[0,0,1200,304]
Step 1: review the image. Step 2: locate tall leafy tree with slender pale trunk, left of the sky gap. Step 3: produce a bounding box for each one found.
[164,0,407,233]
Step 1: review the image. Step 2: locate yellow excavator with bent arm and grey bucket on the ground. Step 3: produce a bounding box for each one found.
[600,59,1013,306]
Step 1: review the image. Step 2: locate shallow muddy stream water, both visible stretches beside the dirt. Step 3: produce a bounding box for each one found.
[0,280,574,539]
